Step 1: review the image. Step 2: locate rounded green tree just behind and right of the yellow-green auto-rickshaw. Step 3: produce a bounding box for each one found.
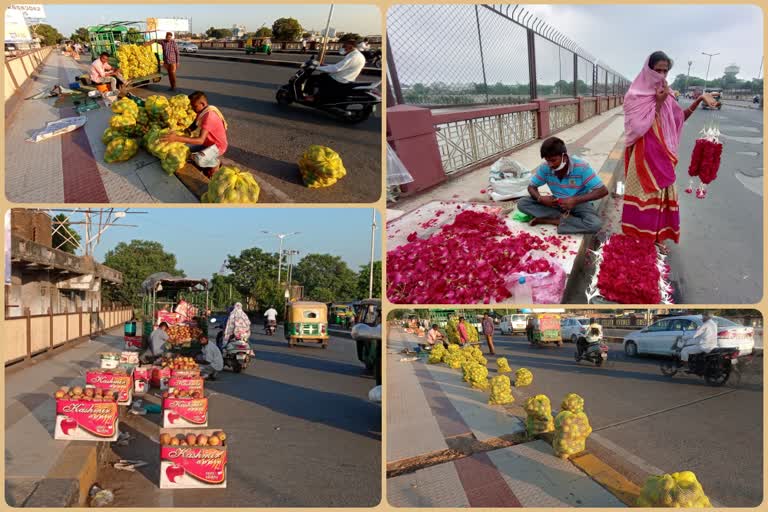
[293,254,357,302]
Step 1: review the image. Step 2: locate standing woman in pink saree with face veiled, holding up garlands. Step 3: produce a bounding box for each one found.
[621,52,715,245]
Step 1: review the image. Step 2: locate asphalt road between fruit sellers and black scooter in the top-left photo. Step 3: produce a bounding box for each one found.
[138,56,382,203]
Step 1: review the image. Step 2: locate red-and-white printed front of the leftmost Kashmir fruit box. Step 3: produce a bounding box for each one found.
[53,399,119,441]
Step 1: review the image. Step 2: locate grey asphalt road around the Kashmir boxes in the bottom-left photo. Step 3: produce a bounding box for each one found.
[99,327,381,508]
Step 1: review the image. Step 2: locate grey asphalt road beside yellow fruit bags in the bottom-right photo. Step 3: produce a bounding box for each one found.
[482,336,763,507]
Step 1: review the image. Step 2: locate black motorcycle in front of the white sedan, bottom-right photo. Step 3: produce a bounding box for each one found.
[661,338,739,387]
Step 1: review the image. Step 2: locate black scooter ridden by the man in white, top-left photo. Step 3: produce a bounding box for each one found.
[275,54,381,123]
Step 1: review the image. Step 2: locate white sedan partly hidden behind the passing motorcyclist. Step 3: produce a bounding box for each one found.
[623,315,755,357]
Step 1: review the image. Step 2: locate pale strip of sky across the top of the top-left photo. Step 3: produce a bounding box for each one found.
[37,4,381,36]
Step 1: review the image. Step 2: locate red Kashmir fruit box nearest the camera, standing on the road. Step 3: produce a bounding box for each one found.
[160,428,227,489]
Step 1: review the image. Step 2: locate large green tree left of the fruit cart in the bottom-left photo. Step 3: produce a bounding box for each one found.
[104,240,184,309]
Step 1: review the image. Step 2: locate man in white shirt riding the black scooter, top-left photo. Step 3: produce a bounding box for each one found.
[304,39,365,102]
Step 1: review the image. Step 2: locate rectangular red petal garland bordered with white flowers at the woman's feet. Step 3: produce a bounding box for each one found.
[597,234,663,304]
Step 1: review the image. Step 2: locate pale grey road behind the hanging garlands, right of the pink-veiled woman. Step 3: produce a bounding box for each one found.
[670,100,763,304]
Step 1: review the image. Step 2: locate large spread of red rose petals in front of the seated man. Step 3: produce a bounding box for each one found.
[387,210,559,304]
